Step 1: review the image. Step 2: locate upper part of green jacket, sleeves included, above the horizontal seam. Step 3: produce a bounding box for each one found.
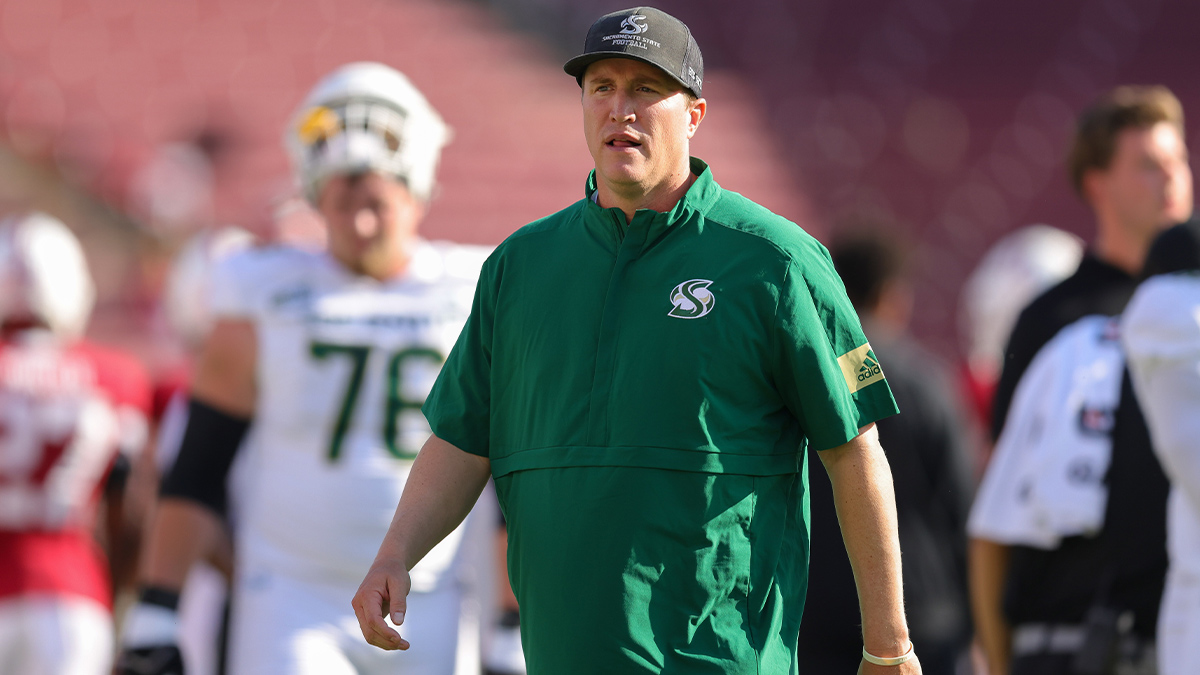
[425,160,896,476]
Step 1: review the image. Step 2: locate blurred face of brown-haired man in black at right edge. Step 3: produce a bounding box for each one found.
[1091,123,1192,239]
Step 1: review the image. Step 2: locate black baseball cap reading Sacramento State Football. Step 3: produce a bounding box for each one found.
[563,7,704,97]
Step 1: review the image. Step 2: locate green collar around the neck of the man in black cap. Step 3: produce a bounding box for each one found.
[583,157,721,251]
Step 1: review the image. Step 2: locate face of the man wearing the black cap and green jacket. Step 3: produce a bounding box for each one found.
[583,58,704,192]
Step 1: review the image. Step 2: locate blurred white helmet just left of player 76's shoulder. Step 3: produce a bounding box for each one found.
[163,227,254,347]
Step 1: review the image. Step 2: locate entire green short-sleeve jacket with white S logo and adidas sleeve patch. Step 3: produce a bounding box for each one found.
[425,160,896,675]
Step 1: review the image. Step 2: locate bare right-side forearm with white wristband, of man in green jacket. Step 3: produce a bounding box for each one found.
[820,424,920,675]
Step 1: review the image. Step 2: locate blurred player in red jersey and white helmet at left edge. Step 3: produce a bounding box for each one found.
[0,214,150,675]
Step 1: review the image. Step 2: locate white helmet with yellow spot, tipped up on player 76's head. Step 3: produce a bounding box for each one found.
[284,62,450,204]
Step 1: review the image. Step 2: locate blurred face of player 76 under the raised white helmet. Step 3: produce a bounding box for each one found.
[317,173,425,279]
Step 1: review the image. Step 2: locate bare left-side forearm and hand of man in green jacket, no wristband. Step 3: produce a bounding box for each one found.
[353,436,492,650]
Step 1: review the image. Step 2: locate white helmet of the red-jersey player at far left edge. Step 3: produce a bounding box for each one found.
[0,213,96,338]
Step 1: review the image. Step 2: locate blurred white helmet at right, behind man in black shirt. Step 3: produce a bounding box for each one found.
[959,225,1084,380]
